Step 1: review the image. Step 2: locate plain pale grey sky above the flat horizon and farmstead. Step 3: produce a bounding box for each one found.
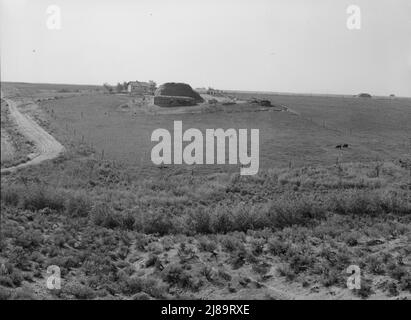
[0,0,411,96]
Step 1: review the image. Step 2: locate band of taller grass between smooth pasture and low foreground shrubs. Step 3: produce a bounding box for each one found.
[1,160,411,235]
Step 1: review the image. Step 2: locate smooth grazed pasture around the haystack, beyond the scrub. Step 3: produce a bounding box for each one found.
[42,94,411,175]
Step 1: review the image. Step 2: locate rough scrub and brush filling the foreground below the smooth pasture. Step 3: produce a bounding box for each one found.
[0,84,411,299]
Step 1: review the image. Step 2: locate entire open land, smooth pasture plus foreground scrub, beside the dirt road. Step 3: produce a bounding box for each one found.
[0,85,411,299]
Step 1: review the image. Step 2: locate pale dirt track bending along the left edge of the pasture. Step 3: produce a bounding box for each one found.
[1,99,64,173]
